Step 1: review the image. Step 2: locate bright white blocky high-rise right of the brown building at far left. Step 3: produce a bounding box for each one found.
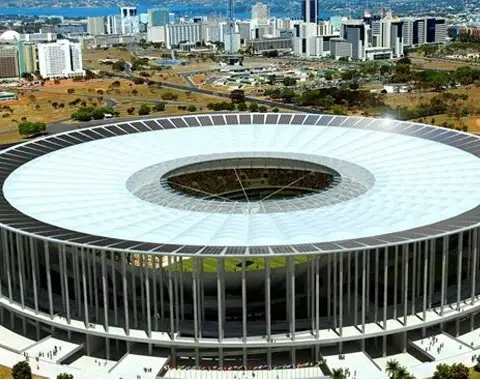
[38,40,85,78]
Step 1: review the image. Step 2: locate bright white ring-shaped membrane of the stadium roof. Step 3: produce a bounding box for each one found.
[3,114,480,246]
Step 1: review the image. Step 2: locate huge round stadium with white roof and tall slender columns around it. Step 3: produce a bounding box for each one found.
[0,113,480,374]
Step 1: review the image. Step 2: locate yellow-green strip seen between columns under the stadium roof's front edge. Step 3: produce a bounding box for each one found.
[172,256,309,272]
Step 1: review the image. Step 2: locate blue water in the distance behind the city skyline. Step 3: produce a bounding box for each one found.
[0,4,331,19]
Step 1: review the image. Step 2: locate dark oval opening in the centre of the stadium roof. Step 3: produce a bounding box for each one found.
[160,157,340,202]
